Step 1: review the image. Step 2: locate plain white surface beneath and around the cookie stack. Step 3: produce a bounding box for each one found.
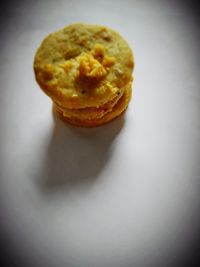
[0,0,200,267]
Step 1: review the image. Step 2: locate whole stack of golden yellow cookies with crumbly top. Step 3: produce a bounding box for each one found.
[34,24,134,127]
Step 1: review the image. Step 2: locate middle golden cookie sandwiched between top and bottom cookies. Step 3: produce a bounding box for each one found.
[54,83,132,120]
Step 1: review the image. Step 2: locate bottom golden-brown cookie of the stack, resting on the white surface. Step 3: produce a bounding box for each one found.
[54,87,132,127]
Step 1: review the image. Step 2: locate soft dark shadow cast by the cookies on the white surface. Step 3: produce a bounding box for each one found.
[35,111,125,195]
